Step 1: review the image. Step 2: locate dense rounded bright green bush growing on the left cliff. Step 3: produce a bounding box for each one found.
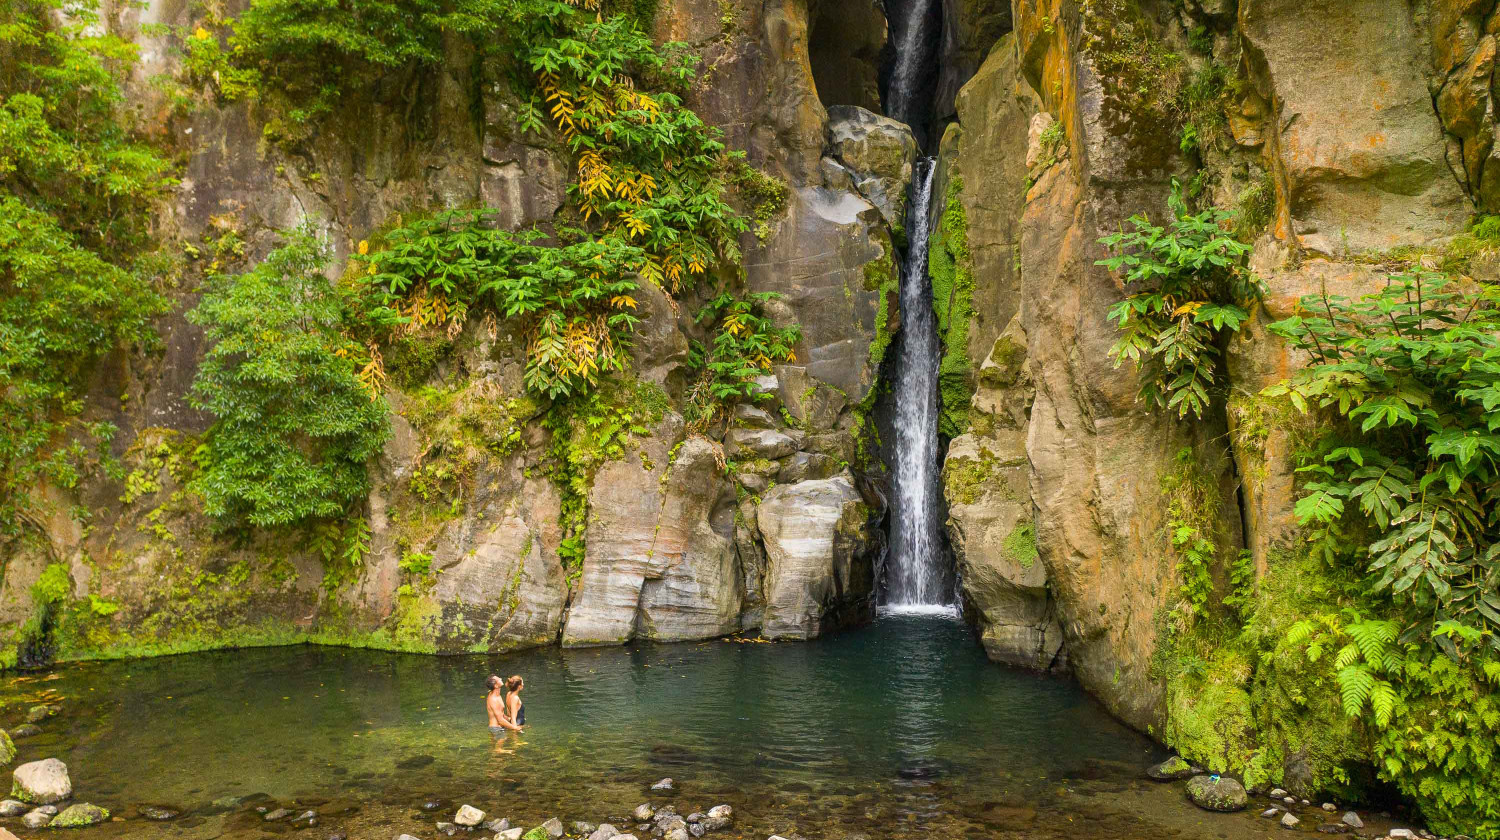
[189,230,387,527]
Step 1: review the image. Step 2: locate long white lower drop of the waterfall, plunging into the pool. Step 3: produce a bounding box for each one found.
[885,158,953,606]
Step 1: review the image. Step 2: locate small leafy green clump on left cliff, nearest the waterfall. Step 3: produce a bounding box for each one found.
[687,293,803,428]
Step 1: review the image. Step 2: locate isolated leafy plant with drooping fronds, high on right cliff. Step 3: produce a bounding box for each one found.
[1097,179,1262,419]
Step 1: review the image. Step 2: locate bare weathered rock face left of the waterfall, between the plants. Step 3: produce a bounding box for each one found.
[0,0,888,659]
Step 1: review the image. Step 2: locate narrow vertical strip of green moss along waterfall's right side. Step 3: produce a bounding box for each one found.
[927,177,974,438]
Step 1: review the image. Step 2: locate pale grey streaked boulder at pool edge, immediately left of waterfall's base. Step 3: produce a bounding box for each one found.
[756,473,875,639]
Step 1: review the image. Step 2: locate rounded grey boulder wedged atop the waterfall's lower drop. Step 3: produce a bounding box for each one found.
[828,105,917,228]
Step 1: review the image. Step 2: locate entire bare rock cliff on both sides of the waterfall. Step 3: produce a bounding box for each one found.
[0,0,1500,810]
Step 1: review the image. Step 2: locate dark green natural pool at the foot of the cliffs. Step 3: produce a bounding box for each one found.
[0,615,1268,840]
